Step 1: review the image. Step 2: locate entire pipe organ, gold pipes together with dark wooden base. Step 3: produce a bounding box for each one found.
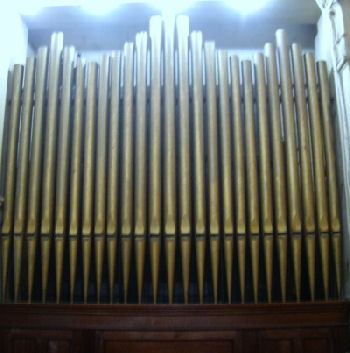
[0,16,350,353]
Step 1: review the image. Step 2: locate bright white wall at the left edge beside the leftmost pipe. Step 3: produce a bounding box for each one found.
[0,4,28,153]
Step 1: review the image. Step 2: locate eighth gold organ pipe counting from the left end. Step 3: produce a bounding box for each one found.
[94,55,110,303]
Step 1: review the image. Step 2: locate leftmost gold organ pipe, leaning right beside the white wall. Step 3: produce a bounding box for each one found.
[1,65,23,302]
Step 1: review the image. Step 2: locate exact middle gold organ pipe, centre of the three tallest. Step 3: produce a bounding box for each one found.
[163,17,176,304]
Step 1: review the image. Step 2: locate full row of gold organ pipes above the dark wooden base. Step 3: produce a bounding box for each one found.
[1,16,342,303]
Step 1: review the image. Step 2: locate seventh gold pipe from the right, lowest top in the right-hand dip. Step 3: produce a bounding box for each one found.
[242,60,259,303]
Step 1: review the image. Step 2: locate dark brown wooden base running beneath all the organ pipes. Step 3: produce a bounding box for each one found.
[0,302,350,353]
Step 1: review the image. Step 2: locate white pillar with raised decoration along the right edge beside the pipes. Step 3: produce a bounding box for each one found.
[315,0,350,298]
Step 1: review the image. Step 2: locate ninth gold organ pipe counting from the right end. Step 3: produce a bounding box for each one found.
[217,50,234,303]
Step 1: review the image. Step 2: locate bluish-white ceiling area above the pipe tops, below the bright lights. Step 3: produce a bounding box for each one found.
[23,0,320,51]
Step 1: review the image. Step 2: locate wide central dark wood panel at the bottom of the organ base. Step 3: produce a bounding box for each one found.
[104,341,234,353]
